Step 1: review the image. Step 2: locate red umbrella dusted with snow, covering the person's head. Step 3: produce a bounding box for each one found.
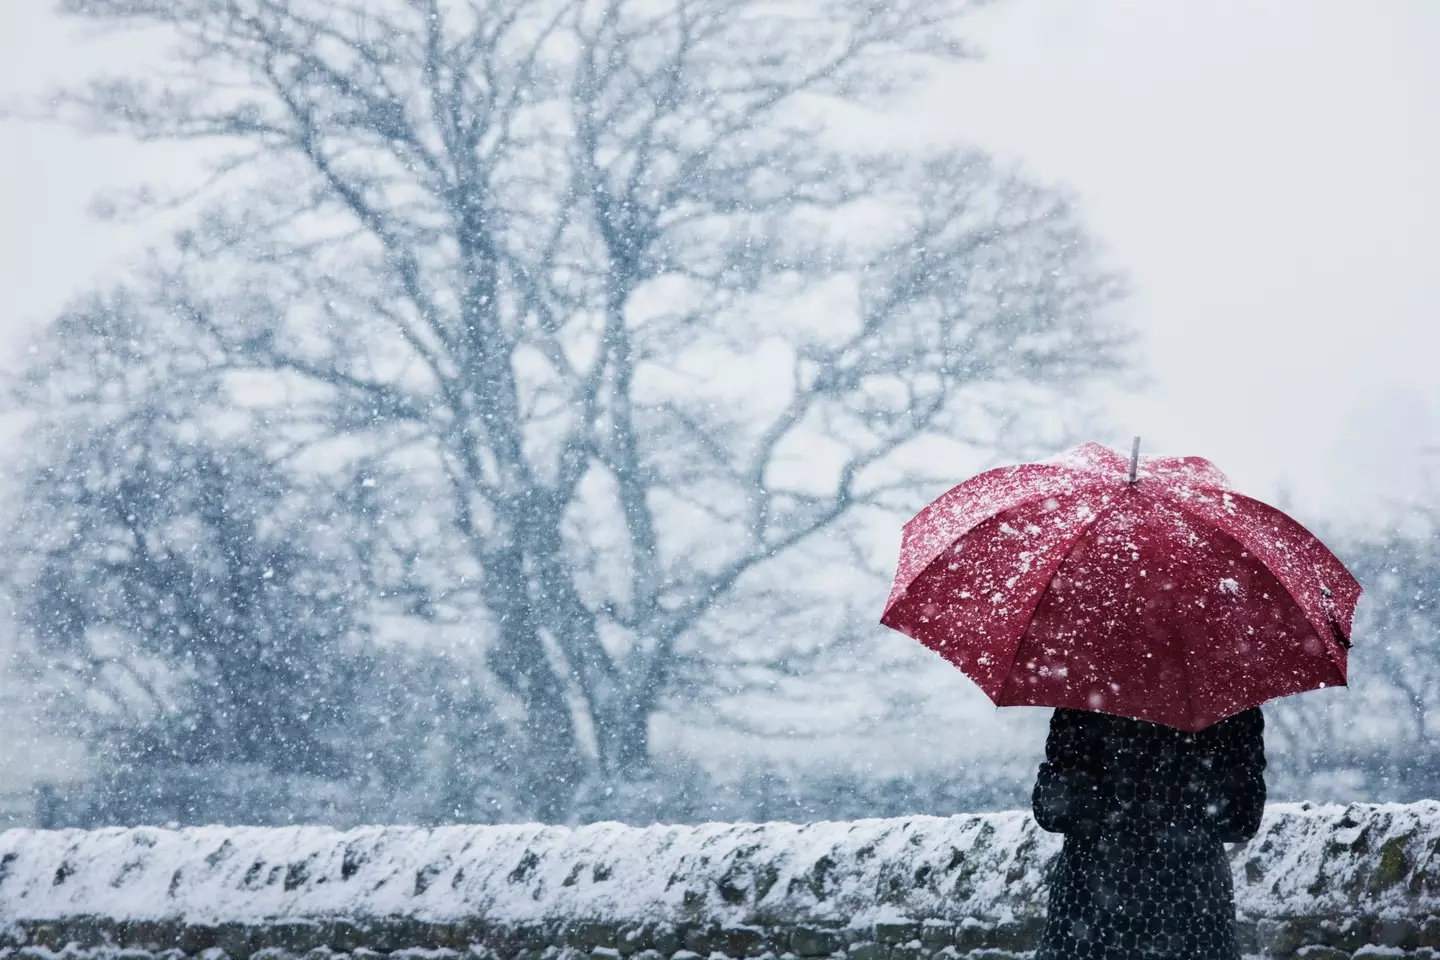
[881,443,1361,731]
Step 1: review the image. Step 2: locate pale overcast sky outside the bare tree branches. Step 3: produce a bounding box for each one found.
[0,0,1440,532]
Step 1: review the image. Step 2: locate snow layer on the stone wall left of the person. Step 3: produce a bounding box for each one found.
[0,813,1057,923]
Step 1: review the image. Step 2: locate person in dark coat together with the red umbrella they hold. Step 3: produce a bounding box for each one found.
[881,440,1361,960]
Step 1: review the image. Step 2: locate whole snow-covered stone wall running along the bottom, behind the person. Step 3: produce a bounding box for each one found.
[0,802,1440,960]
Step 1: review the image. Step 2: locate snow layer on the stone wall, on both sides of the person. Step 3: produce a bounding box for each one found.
[0,800,1440,925]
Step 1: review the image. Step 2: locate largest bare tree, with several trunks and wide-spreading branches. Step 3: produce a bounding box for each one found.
[22,0,1128,818]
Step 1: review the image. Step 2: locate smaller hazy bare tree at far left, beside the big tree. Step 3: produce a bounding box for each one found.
[4,295,364,776]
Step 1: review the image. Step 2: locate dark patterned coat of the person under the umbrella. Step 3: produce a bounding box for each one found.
[1034,710,1264,960]
